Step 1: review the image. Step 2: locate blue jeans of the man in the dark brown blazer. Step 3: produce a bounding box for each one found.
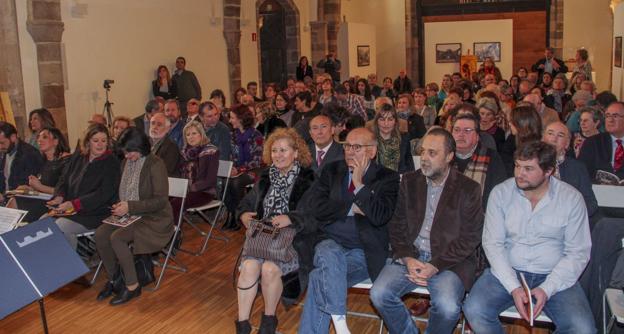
[370,261,465,334]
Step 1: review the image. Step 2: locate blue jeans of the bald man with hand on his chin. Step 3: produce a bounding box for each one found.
[299,239,368,334]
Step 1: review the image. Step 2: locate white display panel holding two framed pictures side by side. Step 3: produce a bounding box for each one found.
[424,19,513,82]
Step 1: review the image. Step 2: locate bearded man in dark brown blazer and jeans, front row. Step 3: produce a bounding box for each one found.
[370,129,483,333]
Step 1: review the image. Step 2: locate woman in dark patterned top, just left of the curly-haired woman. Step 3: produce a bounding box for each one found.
[224,106,264,230]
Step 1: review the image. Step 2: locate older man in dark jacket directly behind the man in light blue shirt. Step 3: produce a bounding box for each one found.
[542,122,598,220]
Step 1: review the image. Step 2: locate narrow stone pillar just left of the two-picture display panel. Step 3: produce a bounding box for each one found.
[405,0,424,86]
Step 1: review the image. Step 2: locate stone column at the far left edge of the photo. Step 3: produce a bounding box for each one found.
[0,0,28,134]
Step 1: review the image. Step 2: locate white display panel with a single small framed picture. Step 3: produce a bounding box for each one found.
[338,22,377,81]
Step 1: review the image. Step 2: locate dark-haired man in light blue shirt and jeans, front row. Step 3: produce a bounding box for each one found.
[464,141,596,334]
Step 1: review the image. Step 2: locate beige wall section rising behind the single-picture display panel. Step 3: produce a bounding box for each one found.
[339,0,405,79]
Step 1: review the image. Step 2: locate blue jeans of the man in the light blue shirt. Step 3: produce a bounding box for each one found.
[464,268,596,334]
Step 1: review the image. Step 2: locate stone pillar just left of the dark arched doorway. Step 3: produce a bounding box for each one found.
[223,0,241,103]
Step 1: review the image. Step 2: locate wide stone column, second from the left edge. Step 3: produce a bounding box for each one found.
[26,0,67,133]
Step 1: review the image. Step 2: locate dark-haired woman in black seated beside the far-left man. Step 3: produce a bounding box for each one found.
[7,128,70,222]
